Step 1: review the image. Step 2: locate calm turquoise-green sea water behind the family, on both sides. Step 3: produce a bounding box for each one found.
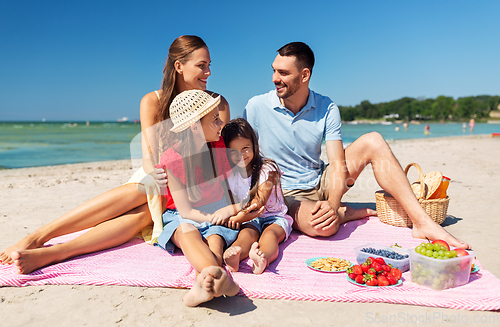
[0,122,500,169]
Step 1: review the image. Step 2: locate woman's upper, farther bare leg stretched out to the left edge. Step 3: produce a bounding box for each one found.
[0,184,149,264]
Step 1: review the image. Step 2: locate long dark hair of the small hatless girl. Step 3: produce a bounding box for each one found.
[221,118,281,206]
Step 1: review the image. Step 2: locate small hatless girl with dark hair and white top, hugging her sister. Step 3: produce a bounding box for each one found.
[222,118,293,274]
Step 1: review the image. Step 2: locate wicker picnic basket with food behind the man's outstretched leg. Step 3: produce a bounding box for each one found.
[375,163,450,227]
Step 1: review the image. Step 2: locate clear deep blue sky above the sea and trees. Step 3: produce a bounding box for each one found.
[0,0,500,121]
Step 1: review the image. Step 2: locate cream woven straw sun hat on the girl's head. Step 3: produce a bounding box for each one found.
[170,90,220,133]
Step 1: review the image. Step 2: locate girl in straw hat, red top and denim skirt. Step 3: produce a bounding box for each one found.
[157,90,260,306]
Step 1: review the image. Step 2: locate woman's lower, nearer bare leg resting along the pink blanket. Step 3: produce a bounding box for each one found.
[12,204,153,274]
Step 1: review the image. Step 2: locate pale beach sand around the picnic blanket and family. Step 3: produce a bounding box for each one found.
[0,135,500,326]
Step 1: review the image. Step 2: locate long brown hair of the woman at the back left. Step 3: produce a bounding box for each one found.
[155,35,208,123]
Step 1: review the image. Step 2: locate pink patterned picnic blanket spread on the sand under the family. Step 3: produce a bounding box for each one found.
[0,217,500,310]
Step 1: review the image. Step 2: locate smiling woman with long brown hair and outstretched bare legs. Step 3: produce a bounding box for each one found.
[0,35,229,274]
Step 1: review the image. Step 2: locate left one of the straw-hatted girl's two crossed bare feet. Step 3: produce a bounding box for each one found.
[183,267,219,307]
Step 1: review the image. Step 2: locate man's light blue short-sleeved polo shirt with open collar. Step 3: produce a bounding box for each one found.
[243,90,342,190]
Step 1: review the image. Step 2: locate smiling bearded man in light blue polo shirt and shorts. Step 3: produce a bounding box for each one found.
[243,42,469,248]
